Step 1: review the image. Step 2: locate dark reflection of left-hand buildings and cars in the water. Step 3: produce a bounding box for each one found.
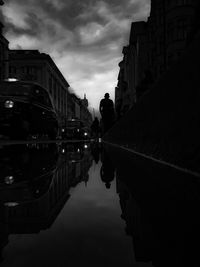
[0,144,92,261]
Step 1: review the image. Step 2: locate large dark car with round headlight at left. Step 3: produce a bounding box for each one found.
[0,81,59,139]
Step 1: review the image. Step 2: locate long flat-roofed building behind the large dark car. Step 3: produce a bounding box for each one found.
[9,50,69,126]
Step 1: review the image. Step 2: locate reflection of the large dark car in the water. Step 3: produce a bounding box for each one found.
[0,144,58,206]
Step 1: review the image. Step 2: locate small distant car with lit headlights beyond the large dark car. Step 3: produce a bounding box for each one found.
[63,119,90,140]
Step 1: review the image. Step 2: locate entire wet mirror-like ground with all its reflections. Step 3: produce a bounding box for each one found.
[0,142,200,267]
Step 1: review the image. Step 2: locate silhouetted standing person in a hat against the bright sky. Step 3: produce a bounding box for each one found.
[99,93,115,134]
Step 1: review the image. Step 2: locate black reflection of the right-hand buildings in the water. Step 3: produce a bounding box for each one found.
[104,147,200,267]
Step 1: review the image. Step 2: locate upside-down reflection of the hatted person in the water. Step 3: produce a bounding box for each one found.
[100,149,115,189]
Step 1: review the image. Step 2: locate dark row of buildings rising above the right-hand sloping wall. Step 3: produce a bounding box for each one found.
[115,0,200,115]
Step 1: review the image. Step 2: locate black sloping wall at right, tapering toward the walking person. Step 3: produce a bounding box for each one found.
[104,32,200,172]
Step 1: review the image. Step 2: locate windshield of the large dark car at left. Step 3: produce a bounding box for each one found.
[0,84,31,96]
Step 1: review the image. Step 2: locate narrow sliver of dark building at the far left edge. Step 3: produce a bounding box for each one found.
[0,22,9,80]
